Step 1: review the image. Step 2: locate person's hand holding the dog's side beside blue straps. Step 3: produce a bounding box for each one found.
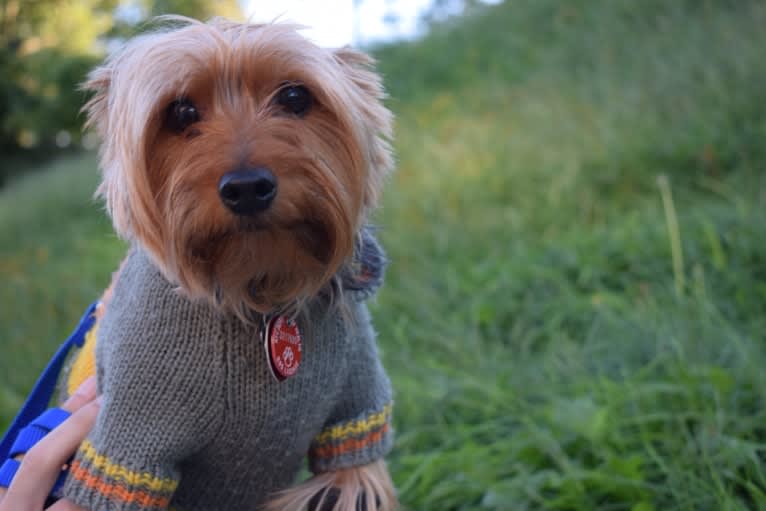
[0,377,99,511]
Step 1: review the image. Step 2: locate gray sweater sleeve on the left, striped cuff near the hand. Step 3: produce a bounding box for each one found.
[62,254,223,511]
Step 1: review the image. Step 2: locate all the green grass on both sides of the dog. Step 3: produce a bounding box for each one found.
[0,0,766,511]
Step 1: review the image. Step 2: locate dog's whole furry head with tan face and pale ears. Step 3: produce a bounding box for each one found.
[86,20,392,312]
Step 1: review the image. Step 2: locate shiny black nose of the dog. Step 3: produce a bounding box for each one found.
[218,167,277,216]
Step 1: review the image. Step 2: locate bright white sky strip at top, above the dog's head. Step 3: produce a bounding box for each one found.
[242,0,460,47]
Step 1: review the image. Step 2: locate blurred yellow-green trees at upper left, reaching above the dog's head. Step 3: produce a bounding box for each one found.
[0,0,241,185]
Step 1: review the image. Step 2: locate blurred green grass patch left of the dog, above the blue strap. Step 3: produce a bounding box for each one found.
[0,155,125,429]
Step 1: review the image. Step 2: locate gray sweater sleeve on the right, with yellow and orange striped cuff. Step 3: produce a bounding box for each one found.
[309,303,393,473]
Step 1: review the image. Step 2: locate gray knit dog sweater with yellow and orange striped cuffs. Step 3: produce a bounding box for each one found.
[63,244,391,511]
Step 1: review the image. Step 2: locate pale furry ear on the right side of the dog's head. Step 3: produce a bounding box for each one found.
[334,47,394,208]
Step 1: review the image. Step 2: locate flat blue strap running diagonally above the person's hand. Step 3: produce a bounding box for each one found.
[0,302,98,466]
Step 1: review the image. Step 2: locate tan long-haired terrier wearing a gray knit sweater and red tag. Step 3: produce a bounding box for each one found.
[57,17,397,511]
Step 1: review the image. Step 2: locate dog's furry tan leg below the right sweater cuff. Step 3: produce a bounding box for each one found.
[265,460,397,511]
